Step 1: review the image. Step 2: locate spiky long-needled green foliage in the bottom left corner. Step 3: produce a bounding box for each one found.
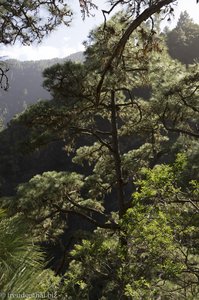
[0,210,58,300]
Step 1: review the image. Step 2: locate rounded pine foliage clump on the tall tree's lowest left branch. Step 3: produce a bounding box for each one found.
[3,171,103,241]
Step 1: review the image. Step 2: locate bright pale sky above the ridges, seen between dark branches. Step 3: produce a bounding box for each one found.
[1,0,199,61]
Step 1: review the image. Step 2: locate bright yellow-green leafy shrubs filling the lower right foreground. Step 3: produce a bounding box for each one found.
[60,154,199,299]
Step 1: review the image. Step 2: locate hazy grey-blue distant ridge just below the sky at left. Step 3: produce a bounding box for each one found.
[0,52,84,126]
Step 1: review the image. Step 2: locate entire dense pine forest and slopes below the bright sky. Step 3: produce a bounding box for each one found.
[0,0,199,300]
